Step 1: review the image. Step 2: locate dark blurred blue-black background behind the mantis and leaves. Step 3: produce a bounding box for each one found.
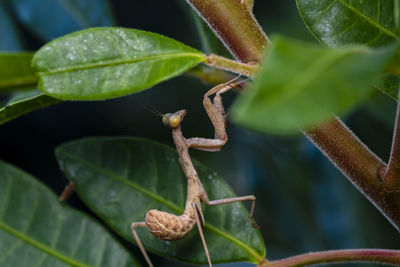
[0,0,400,266]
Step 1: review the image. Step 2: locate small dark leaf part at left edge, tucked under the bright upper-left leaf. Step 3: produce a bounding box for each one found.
[0,89,60,125]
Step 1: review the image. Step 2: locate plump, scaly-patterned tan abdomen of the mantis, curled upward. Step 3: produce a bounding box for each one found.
[145,209,196,241]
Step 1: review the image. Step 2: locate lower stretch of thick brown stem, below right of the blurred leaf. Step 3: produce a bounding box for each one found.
[304,118,400,231]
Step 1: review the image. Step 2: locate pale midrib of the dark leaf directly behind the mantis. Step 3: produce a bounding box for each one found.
[60,150,264,261]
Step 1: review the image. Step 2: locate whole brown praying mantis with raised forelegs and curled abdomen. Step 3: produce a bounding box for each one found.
[131,83,255,266]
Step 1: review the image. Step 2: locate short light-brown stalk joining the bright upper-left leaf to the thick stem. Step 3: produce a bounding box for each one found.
[205,54,258,77]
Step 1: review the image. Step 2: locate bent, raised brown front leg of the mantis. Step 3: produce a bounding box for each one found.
[186,80,239,152]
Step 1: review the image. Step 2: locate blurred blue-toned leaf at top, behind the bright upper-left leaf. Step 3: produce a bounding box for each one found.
[10,0,114,41]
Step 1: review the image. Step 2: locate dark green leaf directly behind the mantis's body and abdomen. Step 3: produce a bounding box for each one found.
[56,137,265,263]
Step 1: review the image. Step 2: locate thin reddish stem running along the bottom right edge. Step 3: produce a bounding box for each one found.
[259,249,400,267]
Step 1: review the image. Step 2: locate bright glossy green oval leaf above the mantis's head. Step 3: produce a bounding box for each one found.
[33,28,205,100]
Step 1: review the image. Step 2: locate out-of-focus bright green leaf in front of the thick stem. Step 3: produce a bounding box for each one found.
[232,36,398,134]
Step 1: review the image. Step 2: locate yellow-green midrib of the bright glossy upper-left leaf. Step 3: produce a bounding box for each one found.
[38,53,205,76]
